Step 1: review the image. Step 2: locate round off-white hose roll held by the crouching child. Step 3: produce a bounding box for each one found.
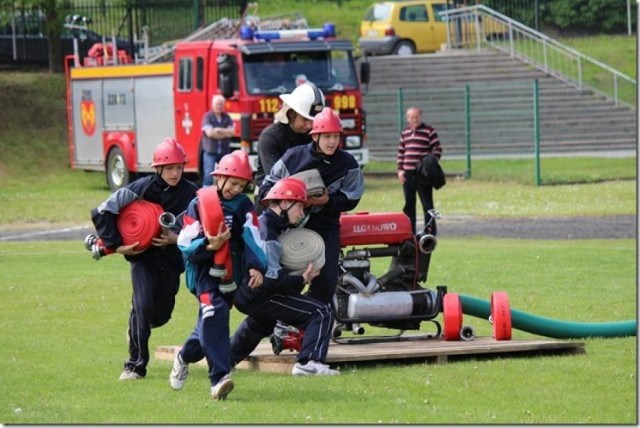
[278,228,324,275]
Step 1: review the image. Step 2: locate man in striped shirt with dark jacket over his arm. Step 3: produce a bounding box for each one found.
[397,107,442,235]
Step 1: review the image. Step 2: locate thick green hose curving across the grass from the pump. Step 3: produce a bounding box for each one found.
[460,294,637,339]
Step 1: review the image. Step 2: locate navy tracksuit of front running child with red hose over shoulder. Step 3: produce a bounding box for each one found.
[178,194,262,386]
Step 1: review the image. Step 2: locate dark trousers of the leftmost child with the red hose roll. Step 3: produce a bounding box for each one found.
[124,259,180,376]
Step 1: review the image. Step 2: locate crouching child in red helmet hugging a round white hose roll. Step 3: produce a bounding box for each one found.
[231,177,340,376]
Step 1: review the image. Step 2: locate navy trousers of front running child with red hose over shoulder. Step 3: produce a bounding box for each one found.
[180,293,231,386]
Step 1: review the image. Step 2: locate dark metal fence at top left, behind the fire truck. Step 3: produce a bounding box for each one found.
[0,0,247,62]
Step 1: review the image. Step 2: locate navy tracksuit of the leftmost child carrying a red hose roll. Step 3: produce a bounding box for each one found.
[91,174,198,377]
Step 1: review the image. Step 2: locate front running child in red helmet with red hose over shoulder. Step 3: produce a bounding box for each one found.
[169,150,264,401]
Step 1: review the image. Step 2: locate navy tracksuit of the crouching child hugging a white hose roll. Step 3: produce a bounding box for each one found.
[231,209,333,365]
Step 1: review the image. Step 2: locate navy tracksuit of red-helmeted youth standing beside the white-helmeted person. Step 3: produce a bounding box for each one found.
[260,143,364,303]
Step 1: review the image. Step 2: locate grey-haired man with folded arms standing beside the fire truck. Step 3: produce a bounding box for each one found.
[202,94,235,187]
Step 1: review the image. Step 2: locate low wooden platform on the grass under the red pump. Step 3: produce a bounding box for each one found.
[155,337,585,374]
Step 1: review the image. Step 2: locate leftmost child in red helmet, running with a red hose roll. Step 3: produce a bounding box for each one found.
[85,138,198,380]
